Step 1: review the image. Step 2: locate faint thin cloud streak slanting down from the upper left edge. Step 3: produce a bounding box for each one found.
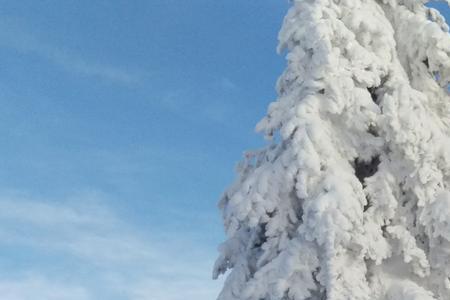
[0,17,141,84]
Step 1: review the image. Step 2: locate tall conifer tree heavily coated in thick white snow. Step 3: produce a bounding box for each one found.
[214,0,450,300]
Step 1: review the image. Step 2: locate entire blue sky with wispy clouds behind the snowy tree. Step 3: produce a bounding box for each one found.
[0,0,450,300]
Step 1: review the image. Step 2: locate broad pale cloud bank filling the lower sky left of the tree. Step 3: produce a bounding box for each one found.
[0,192,220,300]
